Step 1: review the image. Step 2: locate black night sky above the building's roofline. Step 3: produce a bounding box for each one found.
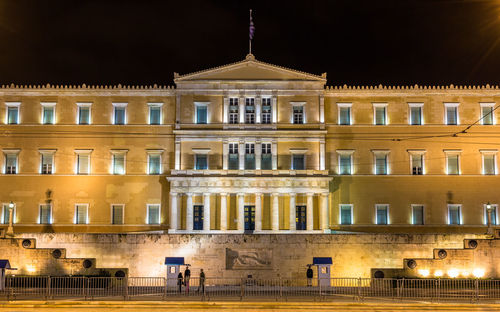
[0,0,500,85]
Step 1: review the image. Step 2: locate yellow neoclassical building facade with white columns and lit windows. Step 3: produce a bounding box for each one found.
[0,55,500,234]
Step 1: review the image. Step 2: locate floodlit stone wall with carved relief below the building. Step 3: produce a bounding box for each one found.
[0,233,497,278]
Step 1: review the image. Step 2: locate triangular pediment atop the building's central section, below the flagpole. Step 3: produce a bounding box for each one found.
[174,55,326,83]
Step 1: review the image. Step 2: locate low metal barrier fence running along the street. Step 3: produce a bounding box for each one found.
[0,276,500,302]
